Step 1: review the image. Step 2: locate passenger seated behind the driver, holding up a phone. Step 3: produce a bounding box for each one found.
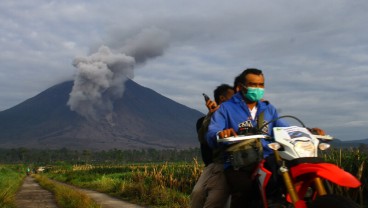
[191,84,234,208]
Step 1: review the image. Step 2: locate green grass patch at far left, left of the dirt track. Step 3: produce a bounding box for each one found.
[0,164,26,208]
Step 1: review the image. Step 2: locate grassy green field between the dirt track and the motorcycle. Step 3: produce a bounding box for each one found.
[47,161,202,208]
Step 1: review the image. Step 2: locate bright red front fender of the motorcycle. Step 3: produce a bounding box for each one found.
[290,163,361,188]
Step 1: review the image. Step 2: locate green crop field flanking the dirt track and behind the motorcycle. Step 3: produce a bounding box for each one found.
[0,149,368,208]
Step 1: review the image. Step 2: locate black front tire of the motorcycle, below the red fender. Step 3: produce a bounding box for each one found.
[308,194,360,208]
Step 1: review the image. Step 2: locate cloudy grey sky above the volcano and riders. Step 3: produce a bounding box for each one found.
[0,0,368,141]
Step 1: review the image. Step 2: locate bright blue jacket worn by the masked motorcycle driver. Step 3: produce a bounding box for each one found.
[206,92,289,157]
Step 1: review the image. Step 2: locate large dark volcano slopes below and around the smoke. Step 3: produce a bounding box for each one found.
[0,80,203,150]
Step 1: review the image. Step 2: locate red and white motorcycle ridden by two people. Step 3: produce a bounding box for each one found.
[217,116,361,208]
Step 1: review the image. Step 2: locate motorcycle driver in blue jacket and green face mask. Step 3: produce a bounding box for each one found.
[206,68,288,208]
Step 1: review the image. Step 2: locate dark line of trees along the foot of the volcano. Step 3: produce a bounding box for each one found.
[0,147,201,165]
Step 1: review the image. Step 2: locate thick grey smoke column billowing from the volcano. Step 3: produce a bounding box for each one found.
[67,28,169,121]
